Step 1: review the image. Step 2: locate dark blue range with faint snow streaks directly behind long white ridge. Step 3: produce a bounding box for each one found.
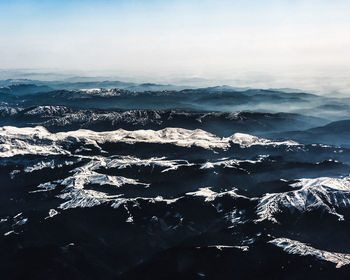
[0,106,326,136]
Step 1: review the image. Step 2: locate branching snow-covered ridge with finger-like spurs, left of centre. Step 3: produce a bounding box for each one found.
[28,156,180,212]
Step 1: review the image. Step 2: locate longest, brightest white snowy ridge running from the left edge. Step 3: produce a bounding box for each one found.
[0,126,299,157]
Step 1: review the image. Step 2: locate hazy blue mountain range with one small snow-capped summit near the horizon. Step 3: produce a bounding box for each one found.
[0,88,323,112]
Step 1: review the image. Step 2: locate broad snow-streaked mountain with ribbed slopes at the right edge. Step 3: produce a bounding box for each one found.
[257,177,350,222]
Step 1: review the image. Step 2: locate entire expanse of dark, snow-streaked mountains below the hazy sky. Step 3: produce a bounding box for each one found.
[0,77,350,279]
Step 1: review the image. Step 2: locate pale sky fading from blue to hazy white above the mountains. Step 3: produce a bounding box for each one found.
[0,0,350,94]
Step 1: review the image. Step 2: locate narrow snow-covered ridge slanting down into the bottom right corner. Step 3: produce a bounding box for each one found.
[269,238,350,268]
